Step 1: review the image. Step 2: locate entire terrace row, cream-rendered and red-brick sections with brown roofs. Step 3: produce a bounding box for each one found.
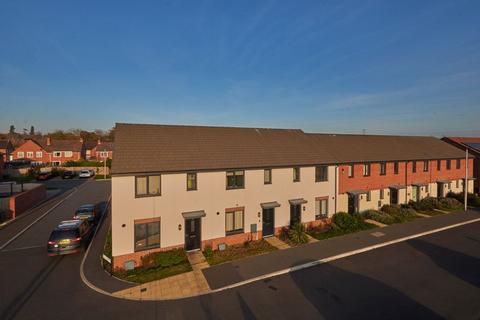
[112,124,473,268]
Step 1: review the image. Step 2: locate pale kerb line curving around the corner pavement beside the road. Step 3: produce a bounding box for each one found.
[80,212,480,301]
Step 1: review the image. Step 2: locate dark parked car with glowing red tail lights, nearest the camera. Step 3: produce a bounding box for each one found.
[47,219,93,256]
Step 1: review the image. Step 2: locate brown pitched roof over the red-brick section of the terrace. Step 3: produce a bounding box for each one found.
[307,133,465,163]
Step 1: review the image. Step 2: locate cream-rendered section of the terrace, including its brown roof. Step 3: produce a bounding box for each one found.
[112,124,337,268]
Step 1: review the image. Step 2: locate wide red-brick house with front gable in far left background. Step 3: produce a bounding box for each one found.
[13,137,85,166]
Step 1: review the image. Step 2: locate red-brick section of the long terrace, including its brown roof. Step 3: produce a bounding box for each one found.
[308,134,473,213]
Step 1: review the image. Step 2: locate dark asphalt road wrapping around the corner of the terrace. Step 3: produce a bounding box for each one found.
[0,182,480,319]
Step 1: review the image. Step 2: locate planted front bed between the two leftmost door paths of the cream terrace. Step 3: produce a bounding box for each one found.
[203,239,277,265]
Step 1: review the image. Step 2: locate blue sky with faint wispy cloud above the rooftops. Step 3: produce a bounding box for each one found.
[0,0,480,135]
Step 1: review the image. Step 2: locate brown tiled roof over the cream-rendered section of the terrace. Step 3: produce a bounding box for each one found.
[112,123,335,174]
